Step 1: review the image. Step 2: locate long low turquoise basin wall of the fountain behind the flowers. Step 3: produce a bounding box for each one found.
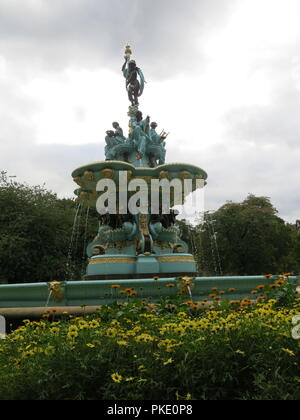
[0,276,300,308]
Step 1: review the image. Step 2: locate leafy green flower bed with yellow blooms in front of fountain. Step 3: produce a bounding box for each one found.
[0,298,300,400]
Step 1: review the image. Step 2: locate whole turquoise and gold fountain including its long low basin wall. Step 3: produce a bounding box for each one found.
[0,46,299,318]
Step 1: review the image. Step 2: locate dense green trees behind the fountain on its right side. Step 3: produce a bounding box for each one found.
[180,195,300,275]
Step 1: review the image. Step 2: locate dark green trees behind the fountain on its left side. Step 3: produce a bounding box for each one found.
[0,172,97,283]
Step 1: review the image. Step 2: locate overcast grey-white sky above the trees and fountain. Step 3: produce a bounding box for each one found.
[0,0,300,222]
